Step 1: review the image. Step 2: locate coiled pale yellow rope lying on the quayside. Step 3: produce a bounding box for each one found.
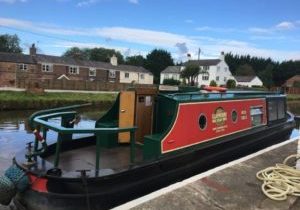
[256,154,300,201]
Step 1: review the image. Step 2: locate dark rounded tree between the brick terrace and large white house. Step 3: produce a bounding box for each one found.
[145,49,174,84]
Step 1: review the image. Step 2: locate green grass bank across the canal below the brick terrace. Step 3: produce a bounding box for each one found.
[0,91,116,110]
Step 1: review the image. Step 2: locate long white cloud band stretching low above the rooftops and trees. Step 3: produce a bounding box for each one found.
[0,18,300,60]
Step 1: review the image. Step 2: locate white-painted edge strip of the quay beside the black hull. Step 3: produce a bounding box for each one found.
[113,136,299,210]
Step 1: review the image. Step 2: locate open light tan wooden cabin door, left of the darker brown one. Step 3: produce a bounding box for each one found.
[119,91,135,143]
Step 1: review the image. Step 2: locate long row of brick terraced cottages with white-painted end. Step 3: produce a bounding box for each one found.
[0,44,153,87]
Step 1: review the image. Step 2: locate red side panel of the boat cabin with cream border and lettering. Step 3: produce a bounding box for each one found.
[161,99,267,153]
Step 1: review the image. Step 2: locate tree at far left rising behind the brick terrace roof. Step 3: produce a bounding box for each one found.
[0,34,22,53]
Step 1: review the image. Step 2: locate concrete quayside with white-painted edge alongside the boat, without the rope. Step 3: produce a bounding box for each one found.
[115,135,300,210]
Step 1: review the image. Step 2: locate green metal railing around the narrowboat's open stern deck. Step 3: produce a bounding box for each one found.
[30,105,137,175]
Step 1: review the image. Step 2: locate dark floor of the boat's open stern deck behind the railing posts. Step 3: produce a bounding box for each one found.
[46,145,142,175]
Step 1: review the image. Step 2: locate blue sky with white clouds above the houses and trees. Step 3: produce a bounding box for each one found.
[0,0,300,61]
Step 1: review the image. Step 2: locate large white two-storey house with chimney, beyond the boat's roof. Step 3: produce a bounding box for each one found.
[160,52,233,86]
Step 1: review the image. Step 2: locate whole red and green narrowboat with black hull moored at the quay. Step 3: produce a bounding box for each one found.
[0,87,295,210]
